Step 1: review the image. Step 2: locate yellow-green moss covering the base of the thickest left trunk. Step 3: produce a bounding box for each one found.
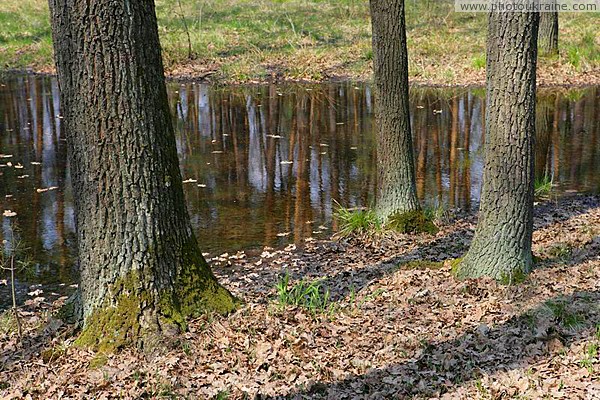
[75,238,239,353]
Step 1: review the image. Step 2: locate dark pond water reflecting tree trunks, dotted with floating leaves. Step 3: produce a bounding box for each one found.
[0,76,600,306]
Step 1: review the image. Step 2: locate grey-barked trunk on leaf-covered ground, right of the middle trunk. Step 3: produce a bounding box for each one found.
[456,12,539,282]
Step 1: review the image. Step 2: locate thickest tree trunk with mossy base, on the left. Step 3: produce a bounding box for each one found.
[49,0,234,349]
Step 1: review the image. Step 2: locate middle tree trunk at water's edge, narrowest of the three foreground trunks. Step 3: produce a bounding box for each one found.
[370,0,420,221]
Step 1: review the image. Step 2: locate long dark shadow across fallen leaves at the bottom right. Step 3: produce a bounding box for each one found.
[268,291,600,400]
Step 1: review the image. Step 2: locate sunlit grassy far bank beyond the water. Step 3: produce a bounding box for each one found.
[0,0,600,85]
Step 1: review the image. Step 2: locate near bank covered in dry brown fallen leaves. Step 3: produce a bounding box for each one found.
[0,195,600,400]
